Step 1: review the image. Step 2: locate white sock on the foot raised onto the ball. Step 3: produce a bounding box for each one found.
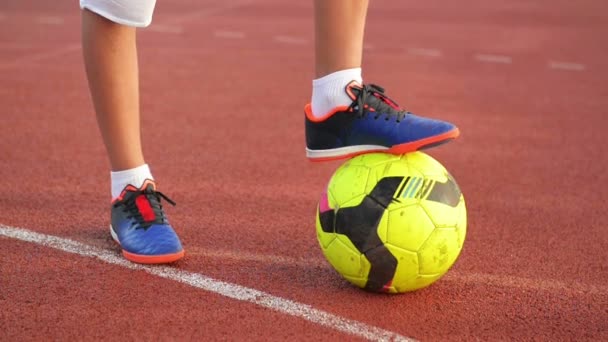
[311,68,363,118]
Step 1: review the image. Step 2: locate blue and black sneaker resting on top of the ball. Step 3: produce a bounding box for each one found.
[304,81,460,161]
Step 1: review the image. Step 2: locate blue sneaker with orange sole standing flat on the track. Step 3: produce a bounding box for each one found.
[110,179,184,264]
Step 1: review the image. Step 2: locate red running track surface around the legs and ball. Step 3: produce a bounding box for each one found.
[0,0,608,341]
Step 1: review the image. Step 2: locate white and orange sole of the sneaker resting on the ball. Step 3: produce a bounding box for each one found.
[306,128,460,162]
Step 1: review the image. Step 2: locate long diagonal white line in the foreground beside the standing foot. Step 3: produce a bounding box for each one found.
[0,224,414,341]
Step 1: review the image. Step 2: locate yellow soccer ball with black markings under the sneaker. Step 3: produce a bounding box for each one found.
[316,152,467,293]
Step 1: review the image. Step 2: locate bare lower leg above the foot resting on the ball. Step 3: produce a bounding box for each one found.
[315,0,369,78]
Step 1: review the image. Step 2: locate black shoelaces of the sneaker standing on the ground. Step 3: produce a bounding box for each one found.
[114,188,176,229]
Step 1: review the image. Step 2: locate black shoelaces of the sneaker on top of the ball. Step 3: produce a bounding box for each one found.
[349,84,408,122]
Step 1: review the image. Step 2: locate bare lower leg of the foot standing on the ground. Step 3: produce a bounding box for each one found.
[82,10,145,171]
